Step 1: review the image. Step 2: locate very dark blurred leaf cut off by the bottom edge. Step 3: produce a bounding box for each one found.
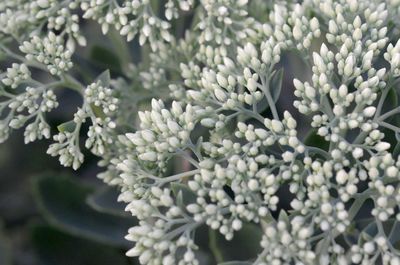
[31,225,128,265]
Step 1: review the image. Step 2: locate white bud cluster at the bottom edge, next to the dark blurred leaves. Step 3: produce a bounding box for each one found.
[122,196,199,265]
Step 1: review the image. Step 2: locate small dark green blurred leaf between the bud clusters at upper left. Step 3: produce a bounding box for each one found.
[89,45,121,73]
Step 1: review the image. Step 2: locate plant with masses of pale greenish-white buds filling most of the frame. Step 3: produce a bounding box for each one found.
[0,0,400,265]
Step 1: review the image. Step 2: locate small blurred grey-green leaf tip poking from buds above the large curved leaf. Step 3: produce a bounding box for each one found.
[86,187,132,218]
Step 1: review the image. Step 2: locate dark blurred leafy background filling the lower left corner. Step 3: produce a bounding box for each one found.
[0,127,139,265]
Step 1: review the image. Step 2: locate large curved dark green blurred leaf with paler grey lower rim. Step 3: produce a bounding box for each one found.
[33,176,134,247]
